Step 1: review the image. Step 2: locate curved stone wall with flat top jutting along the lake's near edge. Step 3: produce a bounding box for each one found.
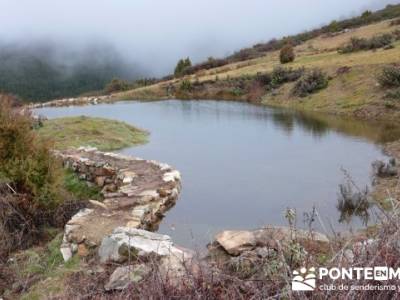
[55,148,181,260]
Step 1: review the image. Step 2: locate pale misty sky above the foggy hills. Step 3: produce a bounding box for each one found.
[0,0,400,75]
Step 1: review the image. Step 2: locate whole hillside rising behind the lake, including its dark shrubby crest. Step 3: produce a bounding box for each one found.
[102,5,400,120]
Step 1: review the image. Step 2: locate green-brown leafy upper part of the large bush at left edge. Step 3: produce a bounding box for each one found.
[0,95,62,210]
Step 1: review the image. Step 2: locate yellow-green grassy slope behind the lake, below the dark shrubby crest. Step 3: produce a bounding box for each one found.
[114,16,400,119]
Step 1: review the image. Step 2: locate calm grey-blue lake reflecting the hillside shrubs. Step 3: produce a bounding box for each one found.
[36,100,398,247]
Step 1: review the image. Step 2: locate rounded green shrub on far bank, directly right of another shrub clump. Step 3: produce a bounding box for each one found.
[292,69,328,97]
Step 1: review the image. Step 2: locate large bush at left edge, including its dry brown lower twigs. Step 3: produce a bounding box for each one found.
[0,95,67,260]
